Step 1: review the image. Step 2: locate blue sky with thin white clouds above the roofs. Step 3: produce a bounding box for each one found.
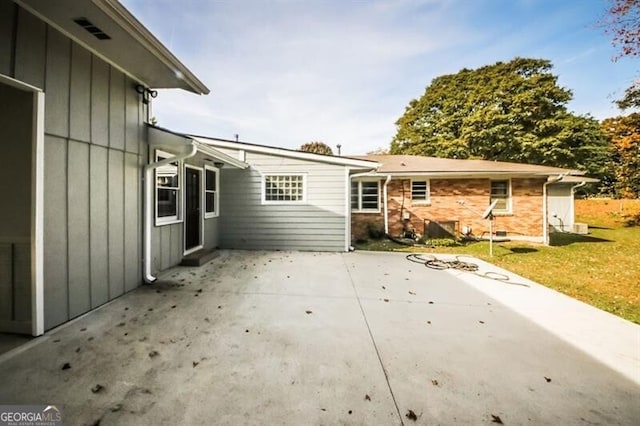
[121,0,640,154]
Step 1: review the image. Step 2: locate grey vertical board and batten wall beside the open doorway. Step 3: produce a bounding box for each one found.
[0,0,147,330]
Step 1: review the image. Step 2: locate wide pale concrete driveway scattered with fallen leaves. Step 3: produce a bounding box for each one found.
[0,251,640,425]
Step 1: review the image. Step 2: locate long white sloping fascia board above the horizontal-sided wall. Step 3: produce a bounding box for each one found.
[191,136,380,169]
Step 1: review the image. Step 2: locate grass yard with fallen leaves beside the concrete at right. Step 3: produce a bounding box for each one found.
[357,199,640,324]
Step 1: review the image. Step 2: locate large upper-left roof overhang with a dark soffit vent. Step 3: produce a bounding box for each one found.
[14,0,209,94]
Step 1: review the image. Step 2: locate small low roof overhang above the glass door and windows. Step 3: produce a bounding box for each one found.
[147,125,249,169]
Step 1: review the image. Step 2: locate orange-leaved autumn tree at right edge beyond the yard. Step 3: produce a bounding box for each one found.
[602,113,640,198]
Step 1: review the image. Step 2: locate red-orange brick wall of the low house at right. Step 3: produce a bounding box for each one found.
[351,178,545,243]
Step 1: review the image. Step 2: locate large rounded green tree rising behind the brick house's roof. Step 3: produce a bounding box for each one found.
[391,58,608,176]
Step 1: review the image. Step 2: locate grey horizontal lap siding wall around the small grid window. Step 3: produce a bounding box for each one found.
[219,149,347,251]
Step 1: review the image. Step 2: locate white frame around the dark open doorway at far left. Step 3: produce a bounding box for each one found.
[0,74,45,336]
